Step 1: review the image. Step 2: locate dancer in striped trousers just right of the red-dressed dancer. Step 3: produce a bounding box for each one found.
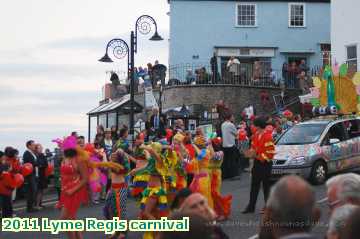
[104,149,131,239]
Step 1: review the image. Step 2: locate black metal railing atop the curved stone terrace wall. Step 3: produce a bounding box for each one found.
[168,61,320,89]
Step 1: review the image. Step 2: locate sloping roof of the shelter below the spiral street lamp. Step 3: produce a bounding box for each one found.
[87,94,142,115]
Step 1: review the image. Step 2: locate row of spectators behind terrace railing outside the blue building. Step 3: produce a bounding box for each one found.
[169,57,311,94]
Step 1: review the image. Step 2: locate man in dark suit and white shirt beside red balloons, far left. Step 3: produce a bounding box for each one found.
[23,140,38,212]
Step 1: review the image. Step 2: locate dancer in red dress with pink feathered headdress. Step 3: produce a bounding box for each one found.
[57,136,88,239]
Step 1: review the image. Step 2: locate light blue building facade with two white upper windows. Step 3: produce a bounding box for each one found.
[169,0,330,79]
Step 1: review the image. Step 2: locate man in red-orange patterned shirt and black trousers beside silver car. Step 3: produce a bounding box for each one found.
[243,117,275,214]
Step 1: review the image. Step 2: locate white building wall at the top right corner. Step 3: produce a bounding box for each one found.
[331,0,360,71]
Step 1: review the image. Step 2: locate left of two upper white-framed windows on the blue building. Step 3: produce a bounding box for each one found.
[236,3,257,27]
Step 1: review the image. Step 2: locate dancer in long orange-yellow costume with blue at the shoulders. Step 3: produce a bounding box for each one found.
[187,135,214,209]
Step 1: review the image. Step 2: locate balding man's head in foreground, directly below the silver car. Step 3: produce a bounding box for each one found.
[267,176,318,232]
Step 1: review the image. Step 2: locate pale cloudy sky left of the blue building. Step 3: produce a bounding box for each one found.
[0,0,169,152]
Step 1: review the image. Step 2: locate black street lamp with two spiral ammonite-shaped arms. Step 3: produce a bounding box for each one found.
[99,15,163,137]
